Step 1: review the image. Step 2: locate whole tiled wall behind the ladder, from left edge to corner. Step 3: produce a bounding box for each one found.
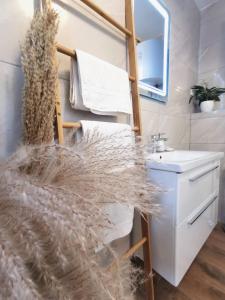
[0,0,199,158]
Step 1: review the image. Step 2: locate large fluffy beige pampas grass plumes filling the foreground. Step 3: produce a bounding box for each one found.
[0,134,158,300]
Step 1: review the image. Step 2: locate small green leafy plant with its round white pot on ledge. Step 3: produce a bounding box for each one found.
[189,85,225,112]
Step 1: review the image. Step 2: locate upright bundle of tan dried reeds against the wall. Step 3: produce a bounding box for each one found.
[21,8,58,144]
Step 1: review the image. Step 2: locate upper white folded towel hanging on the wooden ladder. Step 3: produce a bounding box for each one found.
[70,50,132,115]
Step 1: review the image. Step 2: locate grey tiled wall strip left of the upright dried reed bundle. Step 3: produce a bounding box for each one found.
[0,0,34,158]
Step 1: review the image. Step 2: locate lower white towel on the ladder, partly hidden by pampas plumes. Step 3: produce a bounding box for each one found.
[81,121,134,250]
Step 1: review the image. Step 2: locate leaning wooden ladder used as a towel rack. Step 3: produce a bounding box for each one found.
[44,0,154,300]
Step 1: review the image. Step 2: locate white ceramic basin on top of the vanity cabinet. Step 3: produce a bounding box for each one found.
[147,151,224,173]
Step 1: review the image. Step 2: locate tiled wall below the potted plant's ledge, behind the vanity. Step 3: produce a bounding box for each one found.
[190,111,225,221]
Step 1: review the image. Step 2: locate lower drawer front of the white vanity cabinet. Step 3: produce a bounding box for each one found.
[174,194,218,285]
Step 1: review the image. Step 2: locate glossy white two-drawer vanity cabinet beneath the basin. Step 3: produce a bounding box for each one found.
[149,156,221,286]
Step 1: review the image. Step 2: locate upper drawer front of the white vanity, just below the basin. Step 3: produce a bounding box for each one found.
[176,162,219,225]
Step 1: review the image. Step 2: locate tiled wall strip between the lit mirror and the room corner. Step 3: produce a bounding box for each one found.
[142,0,200,149]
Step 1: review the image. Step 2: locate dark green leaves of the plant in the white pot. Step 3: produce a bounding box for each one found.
[189,85,225,105]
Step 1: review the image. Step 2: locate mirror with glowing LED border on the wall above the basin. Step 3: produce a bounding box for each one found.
[134,0,169,102]
